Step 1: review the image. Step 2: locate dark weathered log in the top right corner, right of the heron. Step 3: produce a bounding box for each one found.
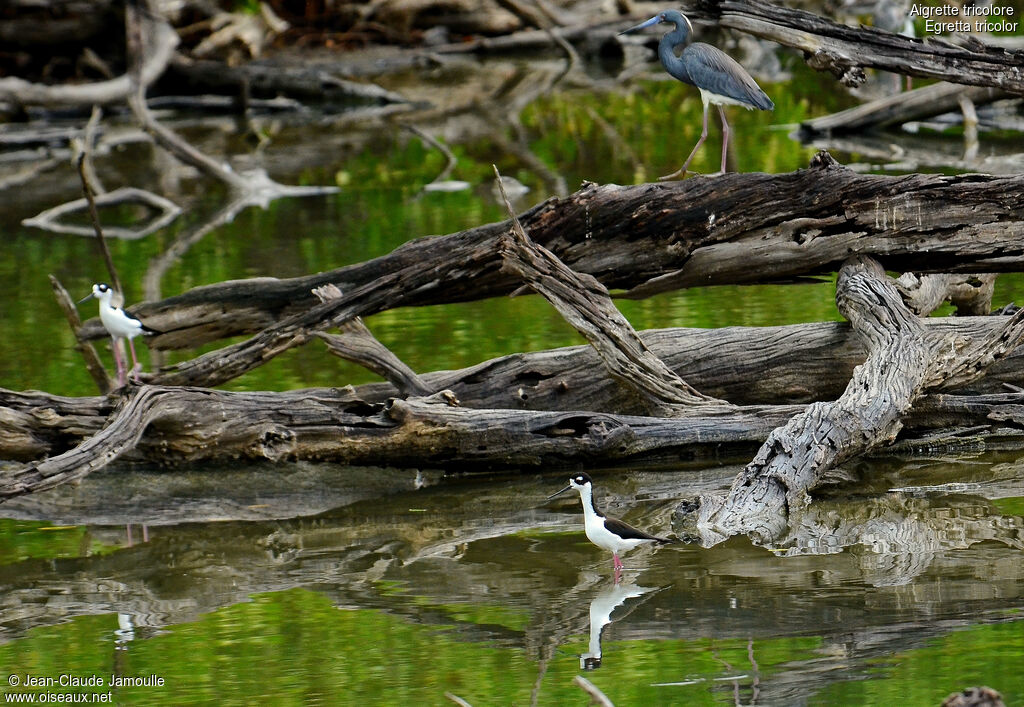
[694,0,1024,95]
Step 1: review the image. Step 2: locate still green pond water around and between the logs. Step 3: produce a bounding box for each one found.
[0,46,1024,705]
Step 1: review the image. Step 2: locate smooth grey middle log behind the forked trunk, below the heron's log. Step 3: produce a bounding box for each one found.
[346,317,1024,409]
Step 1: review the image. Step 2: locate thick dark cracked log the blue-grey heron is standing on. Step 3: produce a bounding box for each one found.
[82,154,1024,358]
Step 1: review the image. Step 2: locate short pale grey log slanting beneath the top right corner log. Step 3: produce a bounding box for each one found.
[800,81,1008,138]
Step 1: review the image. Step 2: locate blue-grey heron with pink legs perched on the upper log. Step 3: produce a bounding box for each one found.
[618,10,775,179]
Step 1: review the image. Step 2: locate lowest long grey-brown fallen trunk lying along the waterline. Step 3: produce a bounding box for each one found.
[6,375,1024,499]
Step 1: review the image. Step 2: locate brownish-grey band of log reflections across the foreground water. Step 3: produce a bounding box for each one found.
[0,469,1024,654]
